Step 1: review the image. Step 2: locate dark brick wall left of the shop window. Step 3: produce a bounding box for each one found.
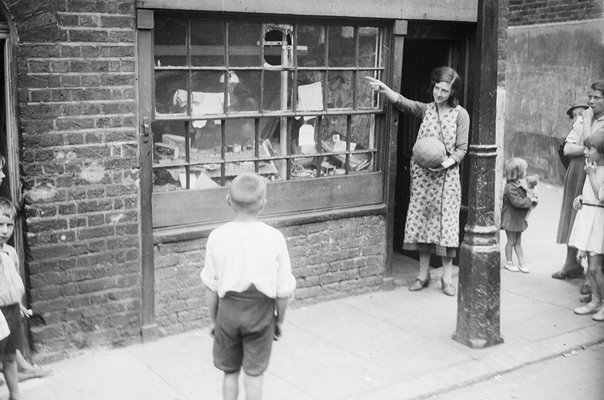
[9,0,141,358]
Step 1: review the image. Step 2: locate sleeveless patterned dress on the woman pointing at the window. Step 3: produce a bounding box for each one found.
[403,103,463,257]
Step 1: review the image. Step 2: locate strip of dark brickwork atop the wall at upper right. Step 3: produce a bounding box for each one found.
[508,0,604,26]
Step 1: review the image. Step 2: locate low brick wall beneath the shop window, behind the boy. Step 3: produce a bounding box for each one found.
[155,216,386,335]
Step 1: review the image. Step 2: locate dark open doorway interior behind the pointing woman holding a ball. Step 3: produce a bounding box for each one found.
[393,21,475,265]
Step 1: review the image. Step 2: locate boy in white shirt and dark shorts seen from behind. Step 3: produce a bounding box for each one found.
[201,174,296,400]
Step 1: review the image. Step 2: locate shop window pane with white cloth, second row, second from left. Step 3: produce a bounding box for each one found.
[191,71,226,118]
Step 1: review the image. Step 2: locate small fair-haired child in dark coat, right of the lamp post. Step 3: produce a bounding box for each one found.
[501,158,538,273]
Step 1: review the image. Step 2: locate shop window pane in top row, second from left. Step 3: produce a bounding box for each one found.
[191,20,225,66]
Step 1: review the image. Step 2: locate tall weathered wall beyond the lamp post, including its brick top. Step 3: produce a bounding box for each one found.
[505,0,604,185]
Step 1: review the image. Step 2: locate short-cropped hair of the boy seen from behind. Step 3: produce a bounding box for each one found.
[229,173,266,213]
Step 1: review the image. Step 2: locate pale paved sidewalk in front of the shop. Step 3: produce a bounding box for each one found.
[5,185,604,400]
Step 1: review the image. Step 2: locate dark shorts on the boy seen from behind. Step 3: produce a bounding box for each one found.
[214,285,275,376]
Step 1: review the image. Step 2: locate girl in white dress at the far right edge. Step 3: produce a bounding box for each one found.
[568,134,604,321]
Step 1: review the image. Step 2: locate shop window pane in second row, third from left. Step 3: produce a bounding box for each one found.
[228,71,260,113]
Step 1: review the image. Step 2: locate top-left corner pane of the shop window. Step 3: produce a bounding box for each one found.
[153,17,187,67]
